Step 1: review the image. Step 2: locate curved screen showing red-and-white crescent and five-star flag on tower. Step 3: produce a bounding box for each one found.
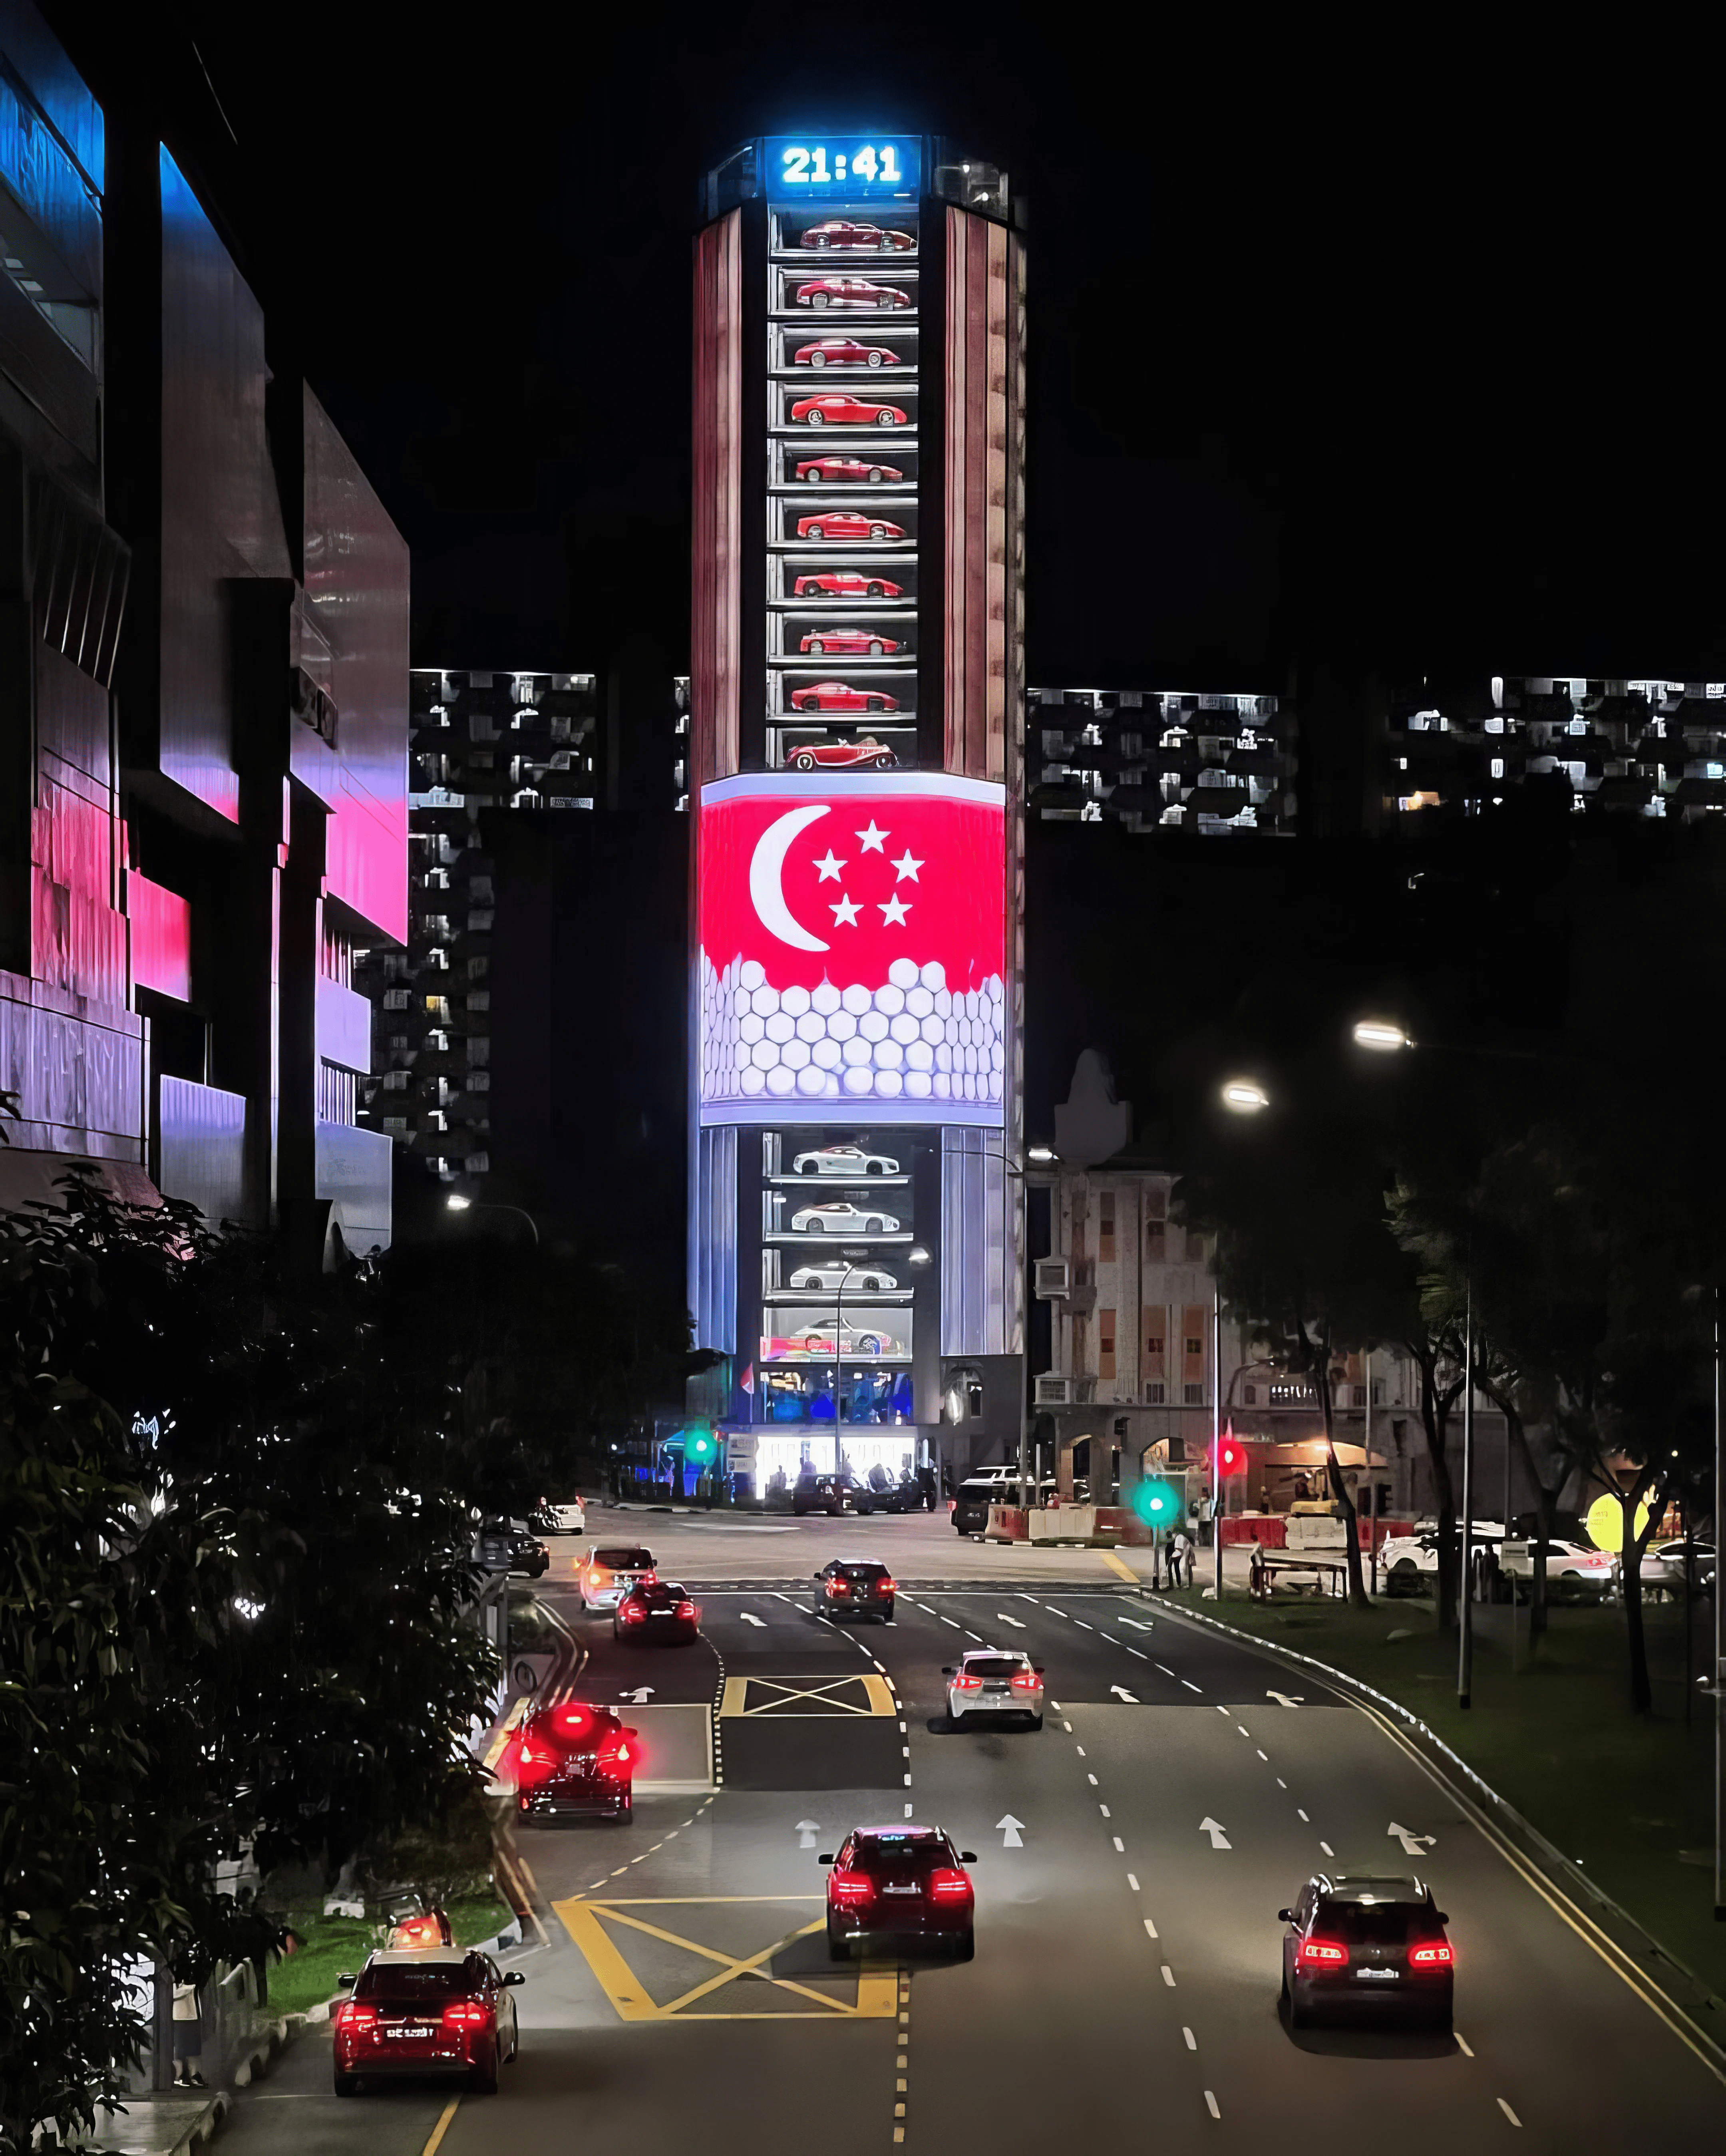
[698,772,1006,1126]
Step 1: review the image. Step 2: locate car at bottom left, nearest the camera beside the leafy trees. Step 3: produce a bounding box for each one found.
[330,1947,524,2096]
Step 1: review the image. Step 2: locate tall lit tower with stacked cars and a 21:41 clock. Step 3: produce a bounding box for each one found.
[690,134,1024,1494]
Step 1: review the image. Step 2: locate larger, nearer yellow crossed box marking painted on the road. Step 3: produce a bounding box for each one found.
[552,1895,899,2022]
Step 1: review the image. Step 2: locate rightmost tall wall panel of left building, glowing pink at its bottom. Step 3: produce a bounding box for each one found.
[302,390,407,942]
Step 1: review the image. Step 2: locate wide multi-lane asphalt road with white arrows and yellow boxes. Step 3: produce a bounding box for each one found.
[215,1516,1726,2156]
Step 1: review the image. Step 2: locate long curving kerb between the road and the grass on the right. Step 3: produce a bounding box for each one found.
[1140,1587,1726,2078]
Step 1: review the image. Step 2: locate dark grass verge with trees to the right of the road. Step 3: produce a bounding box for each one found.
[1168,1589,1726,1997]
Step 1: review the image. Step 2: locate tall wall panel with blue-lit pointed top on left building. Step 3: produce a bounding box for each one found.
[159,149,291,821]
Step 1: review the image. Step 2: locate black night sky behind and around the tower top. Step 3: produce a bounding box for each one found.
[54,0,1726,688]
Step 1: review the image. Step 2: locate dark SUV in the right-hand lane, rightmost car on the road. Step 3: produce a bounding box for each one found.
[1278,1872,1457,2035]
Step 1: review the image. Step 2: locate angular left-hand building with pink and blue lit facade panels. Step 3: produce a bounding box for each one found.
[0,0,407,1259]
